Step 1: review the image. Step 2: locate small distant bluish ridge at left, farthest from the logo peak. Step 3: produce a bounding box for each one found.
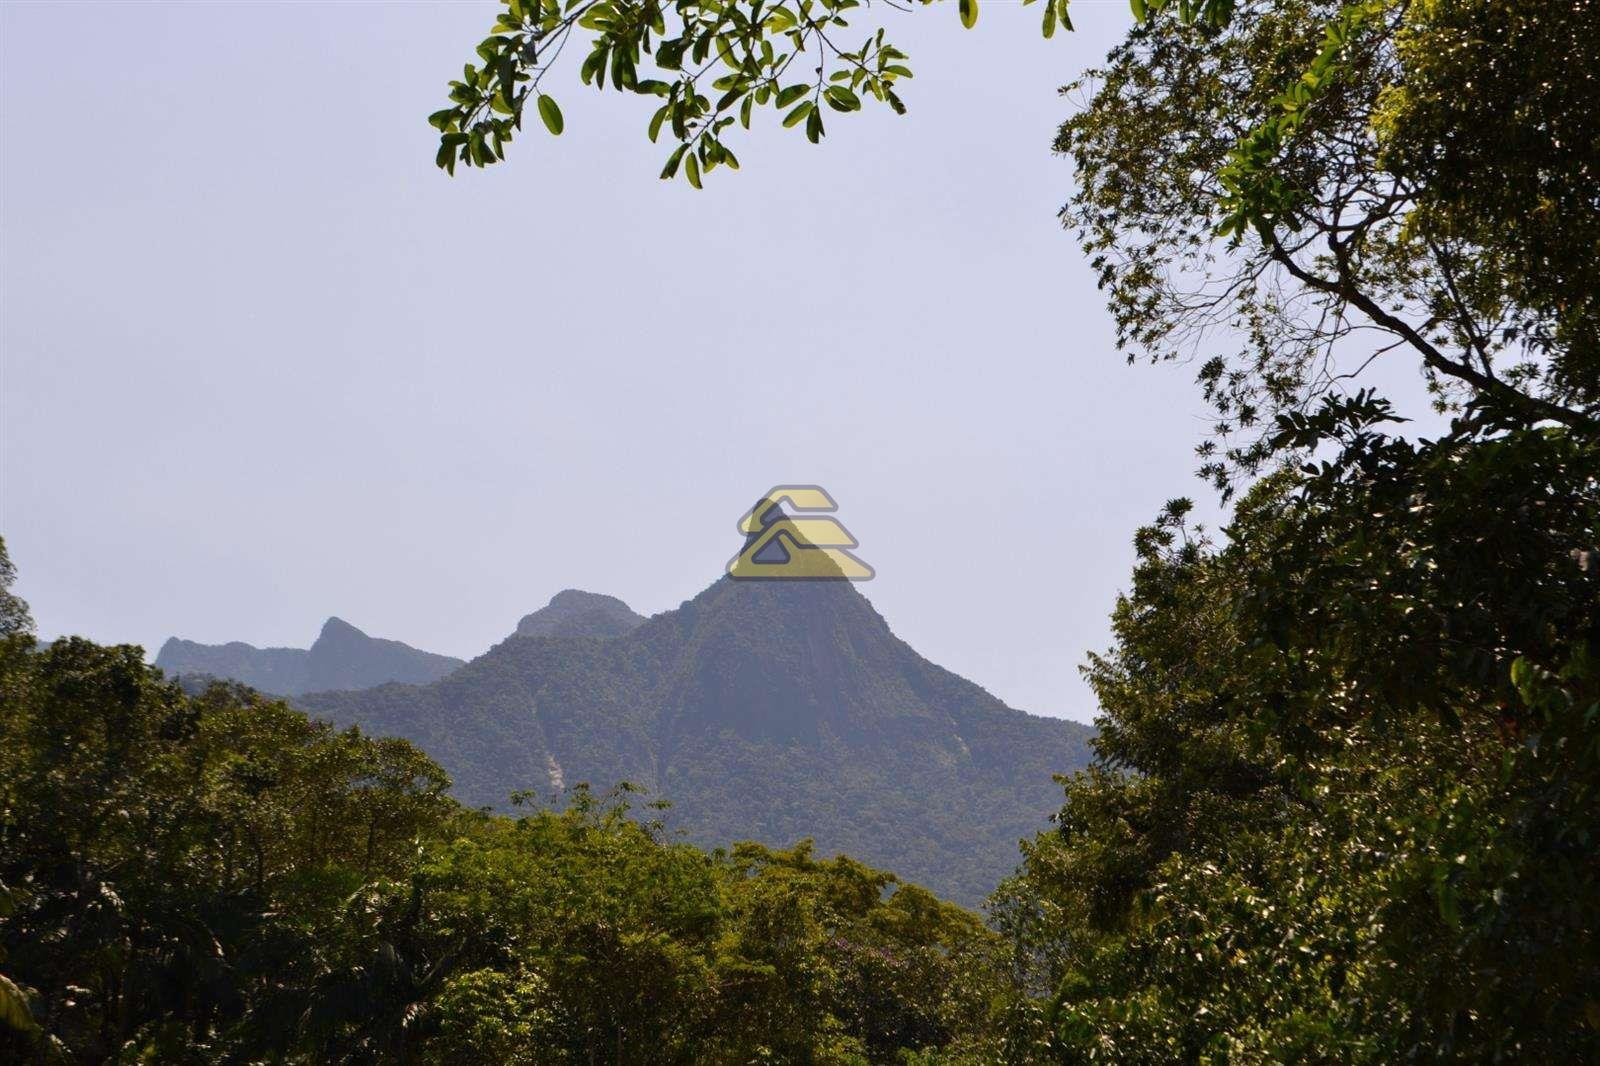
[155,618,462,696]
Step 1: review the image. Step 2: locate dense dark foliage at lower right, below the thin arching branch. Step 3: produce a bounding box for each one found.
[998,399,1600,1063]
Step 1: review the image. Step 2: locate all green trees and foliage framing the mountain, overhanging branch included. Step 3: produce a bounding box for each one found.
[0,0,1600,1063]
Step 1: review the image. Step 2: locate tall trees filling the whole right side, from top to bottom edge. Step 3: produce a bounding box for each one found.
[995,0,1600,1063]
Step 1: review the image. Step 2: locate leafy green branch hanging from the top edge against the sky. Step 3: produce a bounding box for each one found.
[429,0,1234,189]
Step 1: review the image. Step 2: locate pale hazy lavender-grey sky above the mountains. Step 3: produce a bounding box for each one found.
[0,0,1228,719]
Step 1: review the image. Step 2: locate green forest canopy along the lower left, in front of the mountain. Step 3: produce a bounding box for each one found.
[0,611,1000,1063]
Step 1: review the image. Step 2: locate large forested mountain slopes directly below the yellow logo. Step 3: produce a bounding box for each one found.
[296,578,1093,904]
